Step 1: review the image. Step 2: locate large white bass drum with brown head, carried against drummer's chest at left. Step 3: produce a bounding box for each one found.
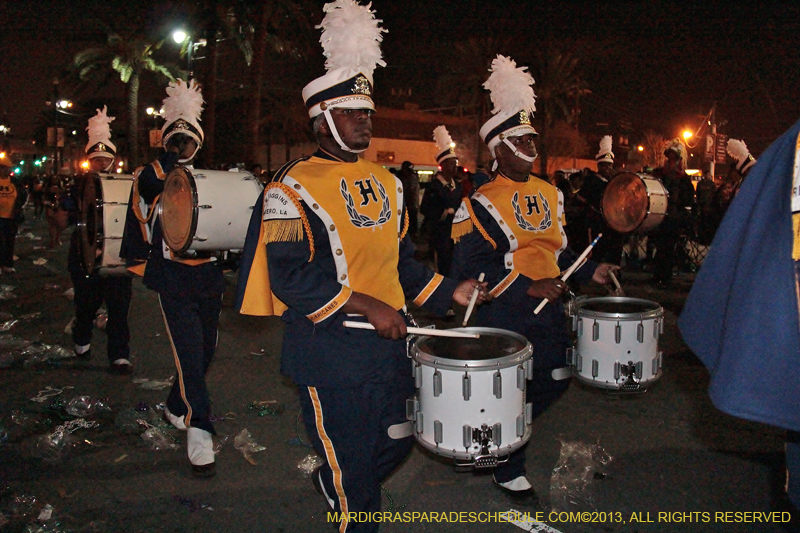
[159,167,263,254]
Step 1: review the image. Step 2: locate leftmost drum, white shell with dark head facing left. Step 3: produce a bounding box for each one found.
[78,174,134,276]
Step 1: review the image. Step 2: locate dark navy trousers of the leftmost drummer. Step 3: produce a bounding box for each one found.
[71,272,131,363]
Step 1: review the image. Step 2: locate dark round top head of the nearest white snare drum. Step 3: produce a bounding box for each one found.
[413,328,531,369]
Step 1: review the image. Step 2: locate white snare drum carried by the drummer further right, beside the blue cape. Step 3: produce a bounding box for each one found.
[567,296,664,392]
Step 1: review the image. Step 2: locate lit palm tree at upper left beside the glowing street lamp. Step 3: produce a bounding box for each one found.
[73,31,180,167]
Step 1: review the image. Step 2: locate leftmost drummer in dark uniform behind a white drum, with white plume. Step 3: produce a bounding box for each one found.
[67,106,133,374]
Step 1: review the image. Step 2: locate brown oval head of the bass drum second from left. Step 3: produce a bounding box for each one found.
[160,167,197,253]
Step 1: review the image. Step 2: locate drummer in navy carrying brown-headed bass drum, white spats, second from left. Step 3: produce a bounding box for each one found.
[120,80,225,477]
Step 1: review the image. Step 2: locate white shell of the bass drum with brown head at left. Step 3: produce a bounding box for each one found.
[162,169,263,252]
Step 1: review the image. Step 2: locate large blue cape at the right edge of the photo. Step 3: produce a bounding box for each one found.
[678,117,800,431]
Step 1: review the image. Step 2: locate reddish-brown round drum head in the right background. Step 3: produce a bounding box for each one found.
[603,172,650,233]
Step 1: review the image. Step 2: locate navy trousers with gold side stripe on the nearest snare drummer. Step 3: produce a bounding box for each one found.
[300,376,414,533]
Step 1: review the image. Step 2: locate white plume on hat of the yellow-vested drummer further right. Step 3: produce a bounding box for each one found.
[483,55,536,114]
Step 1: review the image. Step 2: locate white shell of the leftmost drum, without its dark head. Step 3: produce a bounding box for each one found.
[95,174,134,276]
